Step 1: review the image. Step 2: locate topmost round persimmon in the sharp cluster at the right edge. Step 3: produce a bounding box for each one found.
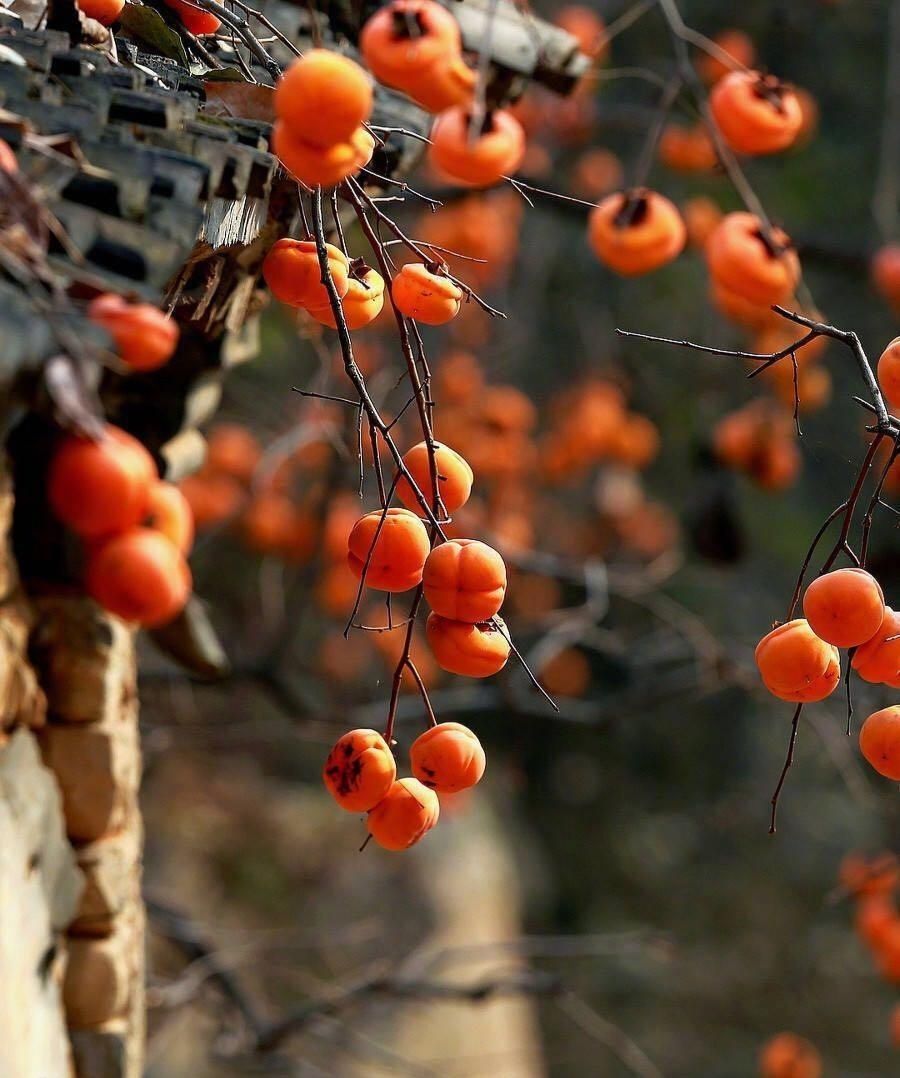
[803,568,885,648]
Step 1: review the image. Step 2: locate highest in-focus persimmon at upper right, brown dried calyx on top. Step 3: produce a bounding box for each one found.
[709,71,803,155]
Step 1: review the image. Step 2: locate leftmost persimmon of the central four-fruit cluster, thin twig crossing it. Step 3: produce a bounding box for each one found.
[347,509,431,592]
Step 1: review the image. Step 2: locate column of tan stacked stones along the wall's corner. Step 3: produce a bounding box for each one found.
[31,596,144,1078]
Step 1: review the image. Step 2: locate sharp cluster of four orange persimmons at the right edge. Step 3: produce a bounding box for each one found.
[756,567,900,782]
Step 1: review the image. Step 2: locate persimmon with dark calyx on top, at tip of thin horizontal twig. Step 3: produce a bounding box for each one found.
[587,189,687,277]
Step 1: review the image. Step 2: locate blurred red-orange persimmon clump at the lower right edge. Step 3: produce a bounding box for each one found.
[840,853,900,1048]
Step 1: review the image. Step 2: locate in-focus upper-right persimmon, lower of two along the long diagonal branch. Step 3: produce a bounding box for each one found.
[706,212,800,306]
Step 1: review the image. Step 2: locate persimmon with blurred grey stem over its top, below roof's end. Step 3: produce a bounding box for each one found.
[428,106,525,188]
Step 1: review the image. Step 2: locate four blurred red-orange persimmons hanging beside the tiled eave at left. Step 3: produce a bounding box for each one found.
[46,293,194,626]
